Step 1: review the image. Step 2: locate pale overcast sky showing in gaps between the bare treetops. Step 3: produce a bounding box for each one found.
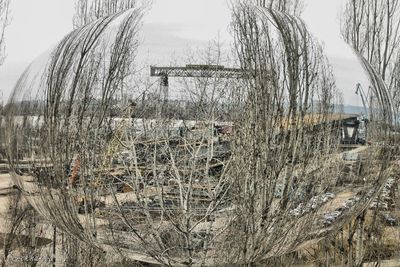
[0,0,366,106]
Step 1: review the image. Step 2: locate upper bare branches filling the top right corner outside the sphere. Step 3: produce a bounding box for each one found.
[342,0,400,119]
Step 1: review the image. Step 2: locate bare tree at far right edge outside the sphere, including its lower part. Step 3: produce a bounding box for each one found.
[342,0,400,264]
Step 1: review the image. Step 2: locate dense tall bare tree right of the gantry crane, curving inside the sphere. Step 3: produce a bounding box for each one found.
[222,3,337,263]
